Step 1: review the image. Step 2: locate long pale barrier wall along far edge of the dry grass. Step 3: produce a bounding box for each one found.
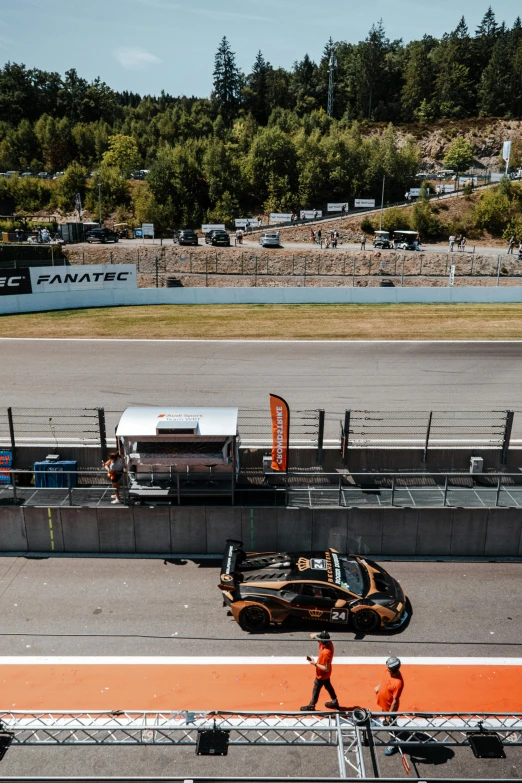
[0,286,522,315]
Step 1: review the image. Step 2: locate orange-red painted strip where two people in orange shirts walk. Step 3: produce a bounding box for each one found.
[0,662,522,712]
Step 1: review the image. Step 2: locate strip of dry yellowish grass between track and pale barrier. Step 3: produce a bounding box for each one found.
[0,304,522,340]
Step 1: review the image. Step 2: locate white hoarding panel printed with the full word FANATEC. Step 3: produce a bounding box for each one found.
[29,264,138,294]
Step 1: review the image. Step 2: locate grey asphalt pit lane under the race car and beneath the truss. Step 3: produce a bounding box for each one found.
[0,558,522,778]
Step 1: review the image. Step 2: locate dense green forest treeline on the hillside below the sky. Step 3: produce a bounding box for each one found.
[0,9,522,227]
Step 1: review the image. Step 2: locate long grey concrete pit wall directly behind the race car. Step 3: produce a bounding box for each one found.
[0,507,522,557]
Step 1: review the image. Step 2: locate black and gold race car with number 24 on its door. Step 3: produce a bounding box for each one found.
[219,539,408,633]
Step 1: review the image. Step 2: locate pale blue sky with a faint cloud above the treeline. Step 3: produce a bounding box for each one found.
[0,0,522,97]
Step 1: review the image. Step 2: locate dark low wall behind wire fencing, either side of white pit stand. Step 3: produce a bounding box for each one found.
[10,444,522,478]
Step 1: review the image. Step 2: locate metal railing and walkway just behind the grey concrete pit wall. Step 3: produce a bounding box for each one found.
[4,468,522,509]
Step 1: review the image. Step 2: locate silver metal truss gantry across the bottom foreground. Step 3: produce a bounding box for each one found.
[0,708,522,780]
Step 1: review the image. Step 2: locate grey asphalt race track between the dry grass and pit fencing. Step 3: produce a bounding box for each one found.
[0,339,522,438]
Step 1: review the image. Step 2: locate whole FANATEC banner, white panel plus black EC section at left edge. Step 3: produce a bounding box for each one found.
[0,264,137,295]
